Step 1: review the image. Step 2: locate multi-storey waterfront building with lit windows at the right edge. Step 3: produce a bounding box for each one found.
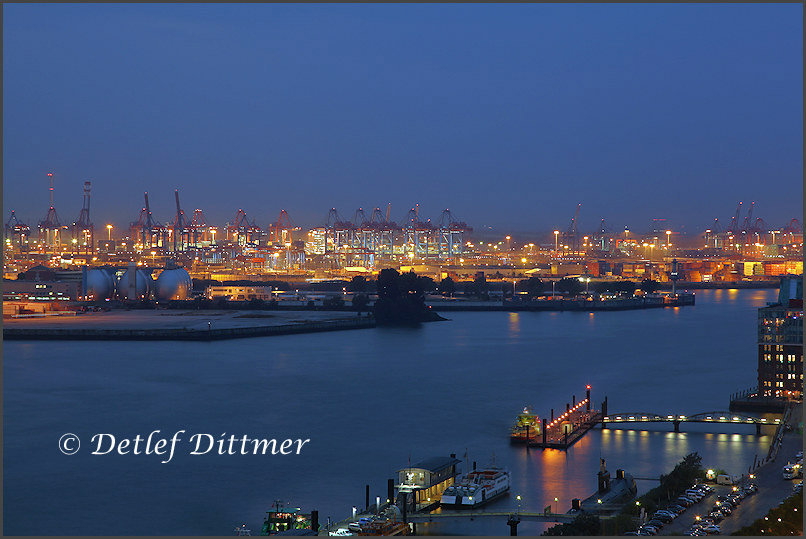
[758,276,803,400]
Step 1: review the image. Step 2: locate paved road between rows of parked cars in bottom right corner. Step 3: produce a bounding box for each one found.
[661,405,803,535]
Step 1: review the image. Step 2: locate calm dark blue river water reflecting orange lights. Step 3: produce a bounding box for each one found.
[3,290,776,535]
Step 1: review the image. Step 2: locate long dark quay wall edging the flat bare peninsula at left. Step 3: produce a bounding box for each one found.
[3,317,376,341]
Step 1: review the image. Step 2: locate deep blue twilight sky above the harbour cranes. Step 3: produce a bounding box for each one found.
[3,4,803,233]
